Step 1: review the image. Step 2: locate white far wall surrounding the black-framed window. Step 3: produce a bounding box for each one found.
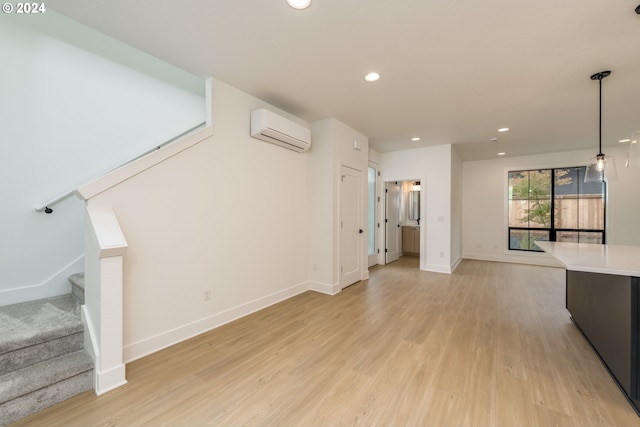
[462,147,640,265]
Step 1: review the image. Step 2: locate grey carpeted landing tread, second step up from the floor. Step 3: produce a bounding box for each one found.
[0,295,83,354]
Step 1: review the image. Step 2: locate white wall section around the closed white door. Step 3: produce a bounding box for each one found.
[309,118,369,294]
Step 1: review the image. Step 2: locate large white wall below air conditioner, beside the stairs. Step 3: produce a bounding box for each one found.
[90,80,310,361]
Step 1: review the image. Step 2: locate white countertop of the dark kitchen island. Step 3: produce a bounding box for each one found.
[536,242,640,277]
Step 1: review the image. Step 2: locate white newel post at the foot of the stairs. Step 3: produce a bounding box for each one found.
[82,203,128,395]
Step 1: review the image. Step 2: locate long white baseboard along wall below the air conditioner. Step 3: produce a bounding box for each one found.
[123,282,310,363]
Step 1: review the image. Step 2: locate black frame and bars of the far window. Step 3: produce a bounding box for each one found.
[507,166,607,252]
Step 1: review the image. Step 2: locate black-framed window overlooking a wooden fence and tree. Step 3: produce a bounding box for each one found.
[509,166,605,252]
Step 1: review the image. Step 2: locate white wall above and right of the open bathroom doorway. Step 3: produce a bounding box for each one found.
[380,145,459,273]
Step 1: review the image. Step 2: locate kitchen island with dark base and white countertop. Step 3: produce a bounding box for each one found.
[536,242,640,415]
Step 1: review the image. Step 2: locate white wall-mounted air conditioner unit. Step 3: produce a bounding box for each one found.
[251,108,311,153]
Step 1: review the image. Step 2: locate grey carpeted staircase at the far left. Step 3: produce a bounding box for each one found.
[0,274,93,427]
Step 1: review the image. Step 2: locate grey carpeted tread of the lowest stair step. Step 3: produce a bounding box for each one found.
[0,350,93,405]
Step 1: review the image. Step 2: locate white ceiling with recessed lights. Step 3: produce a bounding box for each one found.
[47,0,640,160]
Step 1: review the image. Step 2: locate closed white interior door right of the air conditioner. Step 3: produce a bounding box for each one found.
[340,166,364,288]
